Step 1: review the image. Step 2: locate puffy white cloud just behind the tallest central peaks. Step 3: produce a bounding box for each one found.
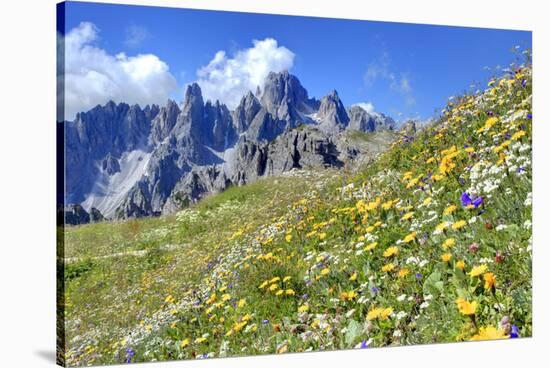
[197,38,294,109]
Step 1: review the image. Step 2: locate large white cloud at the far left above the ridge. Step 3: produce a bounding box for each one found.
[58,22,177,120]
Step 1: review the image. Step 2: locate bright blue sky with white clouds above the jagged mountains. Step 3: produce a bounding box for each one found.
[59,2,531,119]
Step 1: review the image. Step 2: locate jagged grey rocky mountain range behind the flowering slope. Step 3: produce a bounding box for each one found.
[66,71,402,218]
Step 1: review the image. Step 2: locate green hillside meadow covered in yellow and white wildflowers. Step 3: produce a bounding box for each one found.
[62,61,532,365]
